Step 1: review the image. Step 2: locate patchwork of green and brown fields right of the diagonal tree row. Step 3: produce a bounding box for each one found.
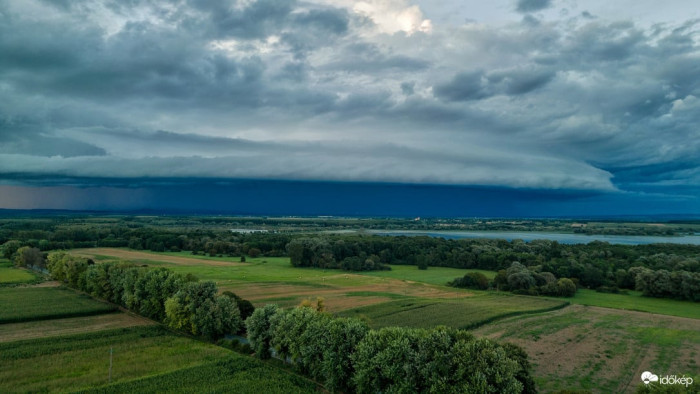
[67,248,700,393]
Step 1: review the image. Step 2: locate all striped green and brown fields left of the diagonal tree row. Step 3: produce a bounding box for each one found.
[0,287,317,393]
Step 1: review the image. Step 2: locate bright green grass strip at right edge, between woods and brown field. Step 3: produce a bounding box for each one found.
[568,289,700,319]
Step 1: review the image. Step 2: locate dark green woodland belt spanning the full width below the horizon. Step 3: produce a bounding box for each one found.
[0,217,700,299]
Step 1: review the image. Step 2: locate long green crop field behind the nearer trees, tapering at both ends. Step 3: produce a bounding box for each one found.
[340,294,568,328]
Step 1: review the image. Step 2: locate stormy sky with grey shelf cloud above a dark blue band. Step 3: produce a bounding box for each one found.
[0,0,700,216]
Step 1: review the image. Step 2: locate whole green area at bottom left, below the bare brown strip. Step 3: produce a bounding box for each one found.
[0,326,313,392]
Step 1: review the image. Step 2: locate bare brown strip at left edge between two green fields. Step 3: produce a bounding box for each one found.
[0,313,155,343]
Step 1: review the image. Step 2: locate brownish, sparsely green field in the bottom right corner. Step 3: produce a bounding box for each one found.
[474,305,700,393]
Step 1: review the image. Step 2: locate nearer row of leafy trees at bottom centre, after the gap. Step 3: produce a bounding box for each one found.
[246,305,536,393]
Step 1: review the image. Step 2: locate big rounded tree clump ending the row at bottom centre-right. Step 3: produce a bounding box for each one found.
[353,327,523,393]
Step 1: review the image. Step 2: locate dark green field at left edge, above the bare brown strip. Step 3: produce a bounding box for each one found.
[0,287,116,323]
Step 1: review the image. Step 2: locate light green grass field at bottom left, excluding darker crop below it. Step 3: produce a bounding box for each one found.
[0,326,284,392]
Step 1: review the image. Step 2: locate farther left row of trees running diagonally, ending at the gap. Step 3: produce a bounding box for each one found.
[47,252,253,339]
